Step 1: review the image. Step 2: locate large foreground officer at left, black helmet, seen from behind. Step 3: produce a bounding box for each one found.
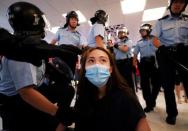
[0,2,74,131]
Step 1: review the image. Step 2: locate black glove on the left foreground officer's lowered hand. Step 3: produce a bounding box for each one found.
[55,106,74,126]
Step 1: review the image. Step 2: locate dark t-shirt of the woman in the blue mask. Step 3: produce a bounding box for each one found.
[75,89,145,131]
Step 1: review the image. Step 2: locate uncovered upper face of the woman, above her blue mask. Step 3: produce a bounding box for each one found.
[85,49,112,73]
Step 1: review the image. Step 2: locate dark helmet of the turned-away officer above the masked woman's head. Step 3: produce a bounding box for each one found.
[90,10,108,26]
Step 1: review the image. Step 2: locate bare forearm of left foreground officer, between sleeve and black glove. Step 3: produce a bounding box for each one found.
[18,85,58,116]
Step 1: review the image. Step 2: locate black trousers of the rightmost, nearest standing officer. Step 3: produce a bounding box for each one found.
[156,46,188,117]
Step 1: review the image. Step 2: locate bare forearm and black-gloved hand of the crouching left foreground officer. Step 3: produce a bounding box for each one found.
[18,85,76,126]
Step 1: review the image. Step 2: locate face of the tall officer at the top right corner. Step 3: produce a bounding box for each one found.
[171,0,185,14]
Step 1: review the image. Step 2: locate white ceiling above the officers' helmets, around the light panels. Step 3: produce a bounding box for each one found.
[0,0,188,42]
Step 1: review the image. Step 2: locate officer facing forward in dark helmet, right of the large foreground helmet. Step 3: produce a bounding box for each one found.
[51,11,86,48]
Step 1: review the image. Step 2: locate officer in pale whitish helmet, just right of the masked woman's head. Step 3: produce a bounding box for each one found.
[114,27,134,91]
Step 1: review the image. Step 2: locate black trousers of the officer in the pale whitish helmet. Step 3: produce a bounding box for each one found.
[116,58,135,92]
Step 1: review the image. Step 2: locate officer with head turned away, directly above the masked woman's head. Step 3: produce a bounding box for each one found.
[88,10,108,48]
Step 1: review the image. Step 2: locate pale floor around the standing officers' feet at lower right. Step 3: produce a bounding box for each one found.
[0,90,188,131]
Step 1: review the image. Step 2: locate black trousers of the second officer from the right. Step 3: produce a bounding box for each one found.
[138,57,161,108]
